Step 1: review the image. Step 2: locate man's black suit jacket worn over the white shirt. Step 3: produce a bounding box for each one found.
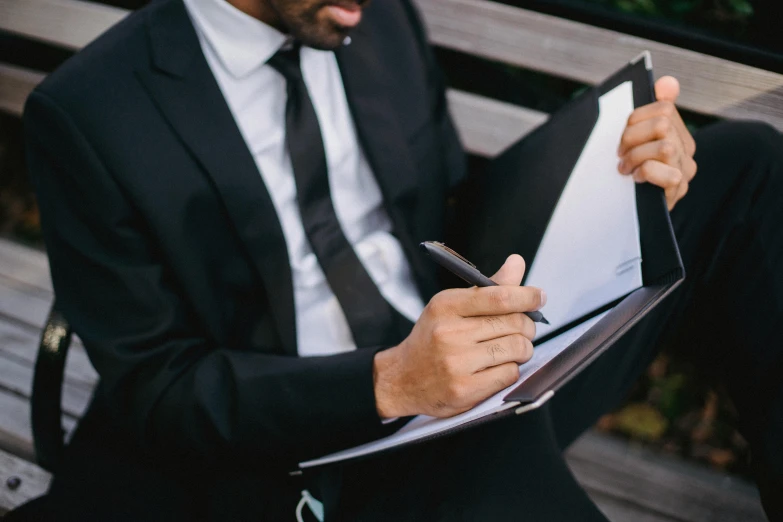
[24,0,464,512]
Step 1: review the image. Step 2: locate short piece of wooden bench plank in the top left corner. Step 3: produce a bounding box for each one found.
[0,0,128,50]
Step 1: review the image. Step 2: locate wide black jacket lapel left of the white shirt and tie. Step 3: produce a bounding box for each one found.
[137,0,296,354]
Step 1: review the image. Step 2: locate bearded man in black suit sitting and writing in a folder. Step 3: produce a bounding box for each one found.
[10,0,783,520]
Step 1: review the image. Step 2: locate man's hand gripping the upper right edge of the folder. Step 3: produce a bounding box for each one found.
[618,76,696,210]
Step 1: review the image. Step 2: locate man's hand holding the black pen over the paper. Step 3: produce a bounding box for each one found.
[374,255,546,418]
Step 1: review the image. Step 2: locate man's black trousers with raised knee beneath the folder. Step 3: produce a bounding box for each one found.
[327,123,783,522]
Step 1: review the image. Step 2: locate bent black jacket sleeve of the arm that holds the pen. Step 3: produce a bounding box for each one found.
[24,92,402,466]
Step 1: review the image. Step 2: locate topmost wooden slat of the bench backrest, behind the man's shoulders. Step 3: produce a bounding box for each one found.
[0,0,783,130]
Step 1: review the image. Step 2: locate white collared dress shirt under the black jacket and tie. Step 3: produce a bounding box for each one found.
[185,0,424,356]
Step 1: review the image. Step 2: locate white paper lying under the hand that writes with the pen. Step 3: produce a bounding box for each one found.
[299,312,608,469]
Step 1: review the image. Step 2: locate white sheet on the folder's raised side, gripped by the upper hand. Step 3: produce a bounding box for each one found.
[525,82,642,338]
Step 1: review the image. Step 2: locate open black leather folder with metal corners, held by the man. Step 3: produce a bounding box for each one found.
[300,53,685,468]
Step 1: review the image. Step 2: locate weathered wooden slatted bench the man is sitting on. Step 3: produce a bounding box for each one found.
[0,0,783,521]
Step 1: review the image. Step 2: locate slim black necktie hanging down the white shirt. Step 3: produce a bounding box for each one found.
[269,45,398,348]
